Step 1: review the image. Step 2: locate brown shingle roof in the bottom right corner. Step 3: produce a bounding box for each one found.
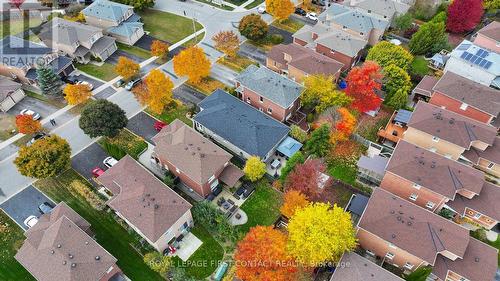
[432,238,498,281]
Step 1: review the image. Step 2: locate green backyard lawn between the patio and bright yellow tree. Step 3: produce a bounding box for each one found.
[236,179,283,234]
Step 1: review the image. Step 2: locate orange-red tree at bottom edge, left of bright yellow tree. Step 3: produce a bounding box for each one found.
[234,226,297,281]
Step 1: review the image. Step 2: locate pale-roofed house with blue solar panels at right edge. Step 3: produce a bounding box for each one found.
[444,40,500,89]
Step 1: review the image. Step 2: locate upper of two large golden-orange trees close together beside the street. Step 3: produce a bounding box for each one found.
[174,46,211,84]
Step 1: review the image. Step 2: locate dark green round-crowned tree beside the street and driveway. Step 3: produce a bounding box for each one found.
[79,99,128,138]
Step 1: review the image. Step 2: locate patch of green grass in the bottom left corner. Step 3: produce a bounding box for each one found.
[0,210,35,281]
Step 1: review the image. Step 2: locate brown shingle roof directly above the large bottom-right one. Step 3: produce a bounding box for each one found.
[386,140,484,199]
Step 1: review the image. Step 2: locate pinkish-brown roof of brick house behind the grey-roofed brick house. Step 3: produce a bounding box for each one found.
[267,44,344,75]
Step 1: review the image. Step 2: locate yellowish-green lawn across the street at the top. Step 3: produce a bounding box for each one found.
[139,9,203,44]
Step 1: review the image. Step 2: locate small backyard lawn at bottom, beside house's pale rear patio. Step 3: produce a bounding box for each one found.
[173,226,224,280]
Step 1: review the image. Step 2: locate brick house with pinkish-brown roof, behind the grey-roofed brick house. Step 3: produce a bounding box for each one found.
[266,44,344,83]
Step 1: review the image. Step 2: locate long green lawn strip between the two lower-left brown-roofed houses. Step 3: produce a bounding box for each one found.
[35,169,164,281]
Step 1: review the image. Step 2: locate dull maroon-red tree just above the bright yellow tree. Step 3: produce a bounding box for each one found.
[285,159,328,200]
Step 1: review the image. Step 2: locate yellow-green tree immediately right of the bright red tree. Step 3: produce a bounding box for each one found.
[384,64,412,109]
